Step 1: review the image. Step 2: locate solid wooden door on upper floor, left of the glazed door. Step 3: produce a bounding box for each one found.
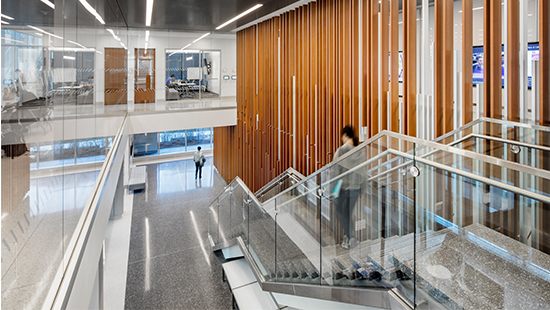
[105,48,128,104]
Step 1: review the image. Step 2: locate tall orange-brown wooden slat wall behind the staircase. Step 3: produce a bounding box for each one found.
[214,0,550,194]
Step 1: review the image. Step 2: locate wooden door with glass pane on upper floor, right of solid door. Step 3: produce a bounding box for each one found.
[134,48,155,103]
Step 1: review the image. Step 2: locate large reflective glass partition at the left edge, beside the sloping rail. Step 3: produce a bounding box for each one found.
[1,0,128,309]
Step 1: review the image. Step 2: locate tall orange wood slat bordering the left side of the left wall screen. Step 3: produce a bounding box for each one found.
[462,0,474,125]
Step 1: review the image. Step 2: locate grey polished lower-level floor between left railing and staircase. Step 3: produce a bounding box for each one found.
[125,157,231,309]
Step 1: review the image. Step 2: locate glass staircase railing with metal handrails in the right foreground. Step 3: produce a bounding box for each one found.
[210,124,550,309]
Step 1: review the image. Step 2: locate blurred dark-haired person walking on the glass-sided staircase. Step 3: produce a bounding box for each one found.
[331,126,364,249]
